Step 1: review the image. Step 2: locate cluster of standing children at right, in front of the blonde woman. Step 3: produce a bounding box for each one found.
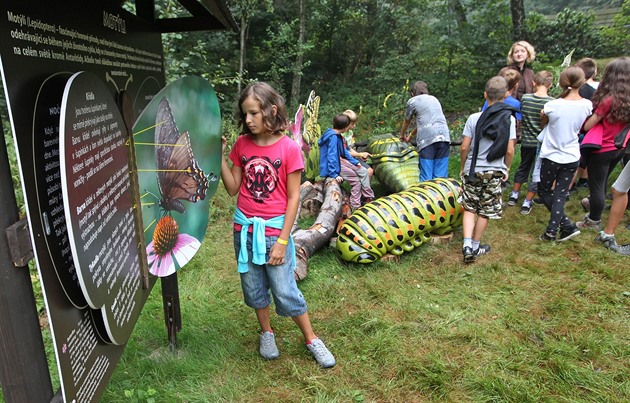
[460,57,630,263]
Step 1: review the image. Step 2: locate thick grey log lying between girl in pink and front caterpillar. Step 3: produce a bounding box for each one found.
[293,179,342,281]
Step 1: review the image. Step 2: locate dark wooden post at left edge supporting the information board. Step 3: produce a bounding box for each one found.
[0,122,54,403]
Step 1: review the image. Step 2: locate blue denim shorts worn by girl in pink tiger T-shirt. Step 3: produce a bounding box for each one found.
[234,232,307,317]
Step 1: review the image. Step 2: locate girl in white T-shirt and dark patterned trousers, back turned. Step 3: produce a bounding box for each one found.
[538,67,593,242]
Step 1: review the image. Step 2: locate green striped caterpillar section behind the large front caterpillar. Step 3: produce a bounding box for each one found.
[368,134,420,193]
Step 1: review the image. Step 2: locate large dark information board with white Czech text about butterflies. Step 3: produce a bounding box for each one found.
[0,0,164,402]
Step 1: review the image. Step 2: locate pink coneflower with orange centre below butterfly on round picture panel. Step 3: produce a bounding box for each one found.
[147,215,201,277]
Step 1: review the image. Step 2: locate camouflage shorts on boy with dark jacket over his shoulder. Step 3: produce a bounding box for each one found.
[461,171,503,219]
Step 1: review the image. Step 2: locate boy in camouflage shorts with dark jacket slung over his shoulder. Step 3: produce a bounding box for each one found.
[460,76,516,263]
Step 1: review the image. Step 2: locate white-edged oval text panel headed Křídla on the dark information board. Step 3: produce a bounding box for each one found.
[59,72,144,345]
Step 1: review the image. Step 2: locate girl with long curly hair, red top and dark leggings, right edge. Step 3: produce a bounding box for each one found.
[576,57,630,229]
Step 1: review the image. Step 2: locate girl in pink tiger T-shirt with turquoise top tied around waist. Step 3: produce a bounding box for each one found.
[221,82,335,368]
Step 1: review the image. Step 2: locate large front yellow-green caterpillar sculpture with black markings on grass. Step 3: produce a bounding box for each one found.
[337,178,463,263]
